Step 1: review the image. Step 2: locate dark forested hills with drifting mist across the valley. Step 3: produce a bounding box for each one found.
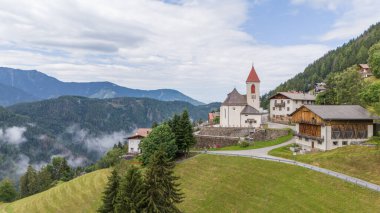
[0,96,220,180]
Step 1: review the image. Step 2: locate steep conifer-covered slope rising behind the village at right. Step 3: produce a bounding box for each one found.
[261,23,380,108]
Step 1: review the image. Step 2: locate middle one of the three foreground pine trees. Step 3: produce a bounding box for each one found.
[115,166,145,213]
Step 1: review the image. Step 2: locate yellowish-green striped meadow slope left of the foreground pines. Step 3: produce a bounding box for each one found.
[0,169,109,213]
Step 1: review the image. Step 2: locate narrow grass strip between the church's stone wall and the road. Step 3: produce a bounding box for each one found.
[209,133,293,151]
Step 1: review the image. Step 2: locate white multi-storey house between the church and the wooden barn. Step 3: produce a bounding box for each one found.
[269,92,315,123]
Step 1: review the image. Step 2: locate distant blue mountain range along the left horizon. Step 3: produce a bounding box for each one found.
[0,67,204,106]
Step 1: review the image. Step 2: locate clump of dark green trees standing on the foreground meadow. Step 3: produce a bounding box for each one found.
[98,110,195,213]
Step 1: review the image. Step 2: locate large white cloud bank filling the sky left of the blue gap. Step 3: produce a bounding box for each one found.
[0,0,329,102]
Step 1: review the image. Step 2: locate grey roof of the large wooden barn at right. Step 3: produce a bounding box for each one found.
[300,105,378,120]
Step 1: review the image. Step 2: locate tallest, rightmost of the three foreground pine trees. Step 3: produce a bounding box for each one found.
[143,150,183,213]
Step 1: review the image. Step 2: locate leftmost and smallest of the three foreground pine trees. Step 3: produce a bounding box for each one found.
[98,169,120,213]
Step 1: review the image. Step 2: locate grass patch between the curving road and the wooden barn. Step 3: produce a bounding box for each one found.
[269,145,380,185]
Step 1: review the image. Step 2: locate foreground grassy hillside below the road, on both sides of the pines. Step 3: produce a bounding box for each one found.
[0,155,380,213]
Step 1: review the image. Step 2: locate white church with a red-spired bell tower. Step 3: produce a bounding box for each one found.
[220,66,262,128]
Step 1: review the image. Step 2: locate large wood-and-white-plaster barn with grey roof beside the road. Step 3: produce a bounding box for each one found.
[291,105,375,151]
